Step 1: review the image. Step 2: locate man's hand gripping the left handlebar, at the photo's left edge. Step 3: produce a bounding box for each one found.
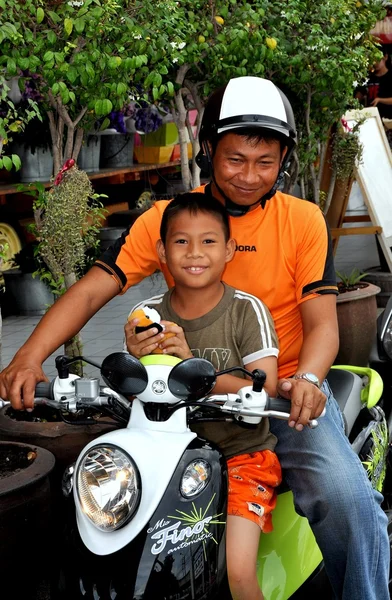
[0,355,48,410]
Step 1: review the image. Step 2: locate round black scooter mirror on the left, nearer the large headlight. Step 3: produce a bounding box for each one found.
[101,352,148,396]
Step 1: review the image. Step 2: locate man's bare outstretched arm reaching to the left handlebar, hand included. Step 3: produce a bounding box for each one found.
[0,267,119,409]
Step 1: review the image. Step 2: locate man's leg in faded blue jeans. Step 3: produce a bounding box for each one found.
[270,384,390,600]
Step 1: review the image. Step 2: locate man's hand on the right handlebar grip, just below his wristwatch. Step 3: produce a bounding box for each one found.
[278,379,327,431]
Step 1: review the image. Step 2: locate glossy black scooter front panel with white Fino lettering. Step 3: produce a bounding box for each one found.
[55,438,230,600]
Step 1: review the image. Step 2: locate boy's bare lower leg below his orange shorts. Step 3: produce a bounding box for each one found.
[226,515,264,600]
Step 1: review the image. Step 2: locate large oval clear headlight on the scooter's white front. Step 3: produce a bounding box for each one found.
[76,445,141,531]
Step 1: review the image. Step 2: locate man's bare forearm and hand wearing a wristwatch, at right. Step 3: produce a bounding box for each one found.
[278,294,339,431]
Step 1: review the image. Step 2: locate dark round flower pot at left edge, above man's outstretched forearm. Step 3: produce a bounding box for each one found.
[3,269,54,317]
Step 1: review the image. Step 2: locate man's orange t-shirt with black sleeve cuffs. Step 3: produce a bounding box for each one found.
[95,187,337,377]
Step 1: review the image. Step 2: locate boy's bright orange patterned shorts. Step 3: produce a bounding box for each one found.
[227,450,282,533]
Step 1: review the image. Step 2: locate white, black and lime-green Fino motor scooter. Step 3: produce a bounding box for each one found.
[32,352,386,600]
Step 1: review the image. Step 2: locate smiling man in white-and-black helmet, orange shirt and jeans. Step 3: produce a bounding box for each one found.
[0,77,389,600]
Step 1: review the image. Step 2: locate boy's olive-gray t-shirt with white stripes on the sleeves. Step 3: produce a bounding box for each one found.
[131,284,279,458]
